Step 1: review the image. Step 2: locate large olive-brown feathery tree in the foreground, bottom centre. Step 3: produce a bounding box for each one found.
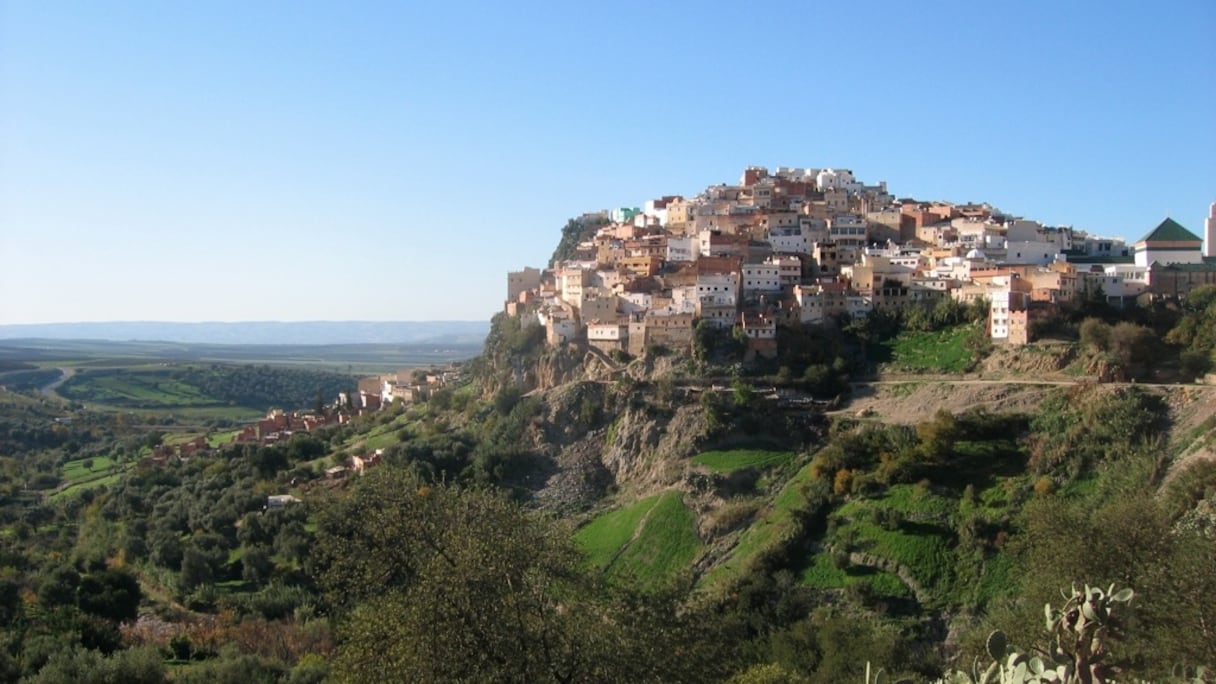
[317,467,725,682]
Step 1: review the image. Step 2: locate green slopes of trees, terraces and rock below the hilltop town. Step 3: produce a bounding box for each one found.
[0,270,1216,683]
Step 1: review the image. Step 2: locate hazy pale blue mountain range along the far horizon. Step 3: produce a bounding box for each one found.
[0,320,490,344]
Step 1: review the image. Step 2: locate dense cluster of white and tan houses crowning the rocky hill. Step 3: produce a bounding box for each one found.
[505,167,1216,357]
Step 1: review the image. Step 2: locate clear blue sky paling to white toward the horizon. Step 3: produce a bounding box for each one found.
[0,0,1216,324]
